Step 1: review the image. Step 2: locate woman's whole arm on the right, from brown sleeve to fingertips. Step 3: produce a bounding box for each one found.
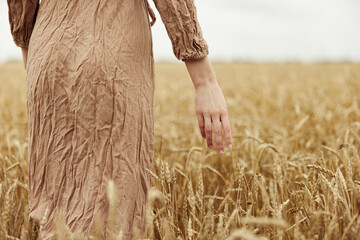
[150,0,231,154]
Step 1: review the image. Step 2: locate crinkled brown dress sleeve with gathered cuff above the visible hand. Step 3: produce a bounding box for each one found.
[153,0,209,61]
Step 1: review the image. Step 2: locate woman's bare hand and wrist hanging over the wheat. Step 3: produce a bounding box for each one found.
[185,57,232,154]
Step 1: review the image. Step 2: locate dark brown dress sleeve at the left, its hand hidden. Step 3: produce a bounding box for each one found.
[7,0,39,48]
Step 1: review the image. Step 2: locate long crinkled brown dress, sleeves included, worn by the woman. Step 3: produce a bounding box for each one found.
[7,0,208,240]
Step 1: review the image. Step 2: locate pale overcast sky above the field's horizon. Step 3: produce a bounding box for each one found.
[0,0,360,62]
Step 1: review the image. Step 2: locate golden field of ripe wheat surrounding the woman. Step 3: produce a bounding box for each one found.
[0,63,360,240]
